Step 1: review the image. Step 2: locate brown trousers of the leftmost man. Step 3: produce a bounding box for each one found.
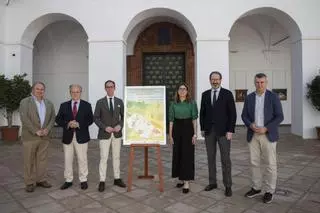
[23,138,49,185]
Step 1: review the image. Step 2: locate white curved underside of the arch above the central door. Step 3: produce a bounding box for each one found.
[123,8,197,55]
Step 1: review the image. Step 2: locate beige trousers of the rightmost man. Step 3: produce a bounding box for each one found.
[249,134,277,194]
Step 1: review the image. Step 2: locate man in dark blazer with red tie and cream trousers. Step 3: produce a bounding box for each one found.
[56,84,93,190]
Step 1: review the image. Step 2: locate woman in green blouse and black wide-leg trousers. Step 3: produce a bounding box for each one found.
[169,83,198,193]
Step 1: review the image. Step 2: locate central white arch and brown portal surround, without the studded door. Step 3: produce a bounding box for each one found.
[123,8,197,98]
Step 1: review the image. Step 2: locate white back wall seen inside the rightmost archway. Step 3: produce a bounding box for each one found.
[229,15,292,124]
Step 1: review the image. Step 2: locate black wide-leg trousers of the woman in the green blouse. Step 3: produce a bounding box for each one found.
[172,119,194,181]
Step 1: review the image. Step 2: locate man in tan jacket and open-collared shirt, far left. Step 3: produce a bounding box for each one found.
[19,82,55,192]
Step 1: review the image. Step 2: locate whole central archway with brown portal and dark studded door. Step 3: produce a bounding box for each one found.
[124,8,196,132]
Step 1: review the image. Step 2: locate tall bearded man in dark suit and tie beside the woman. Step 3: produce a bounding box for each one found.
[200,71,237,197]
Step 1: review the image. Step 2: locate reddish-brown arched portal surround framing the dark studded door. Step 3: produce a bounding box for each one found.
[127,22,195,95]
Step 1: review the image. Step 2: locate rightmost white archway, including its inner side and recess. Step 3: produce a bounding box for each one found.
[229,7,303,135]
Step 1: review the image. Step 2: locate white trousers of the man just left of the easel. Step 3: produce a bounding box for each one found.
[99,134,121,182]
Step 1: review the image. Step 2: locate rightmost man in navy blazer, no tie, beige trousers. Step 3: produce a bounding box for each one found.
[241,73,283,203]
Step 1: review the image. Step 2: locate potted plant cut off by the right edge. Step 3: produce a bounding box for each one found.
[307,75,320,139]
